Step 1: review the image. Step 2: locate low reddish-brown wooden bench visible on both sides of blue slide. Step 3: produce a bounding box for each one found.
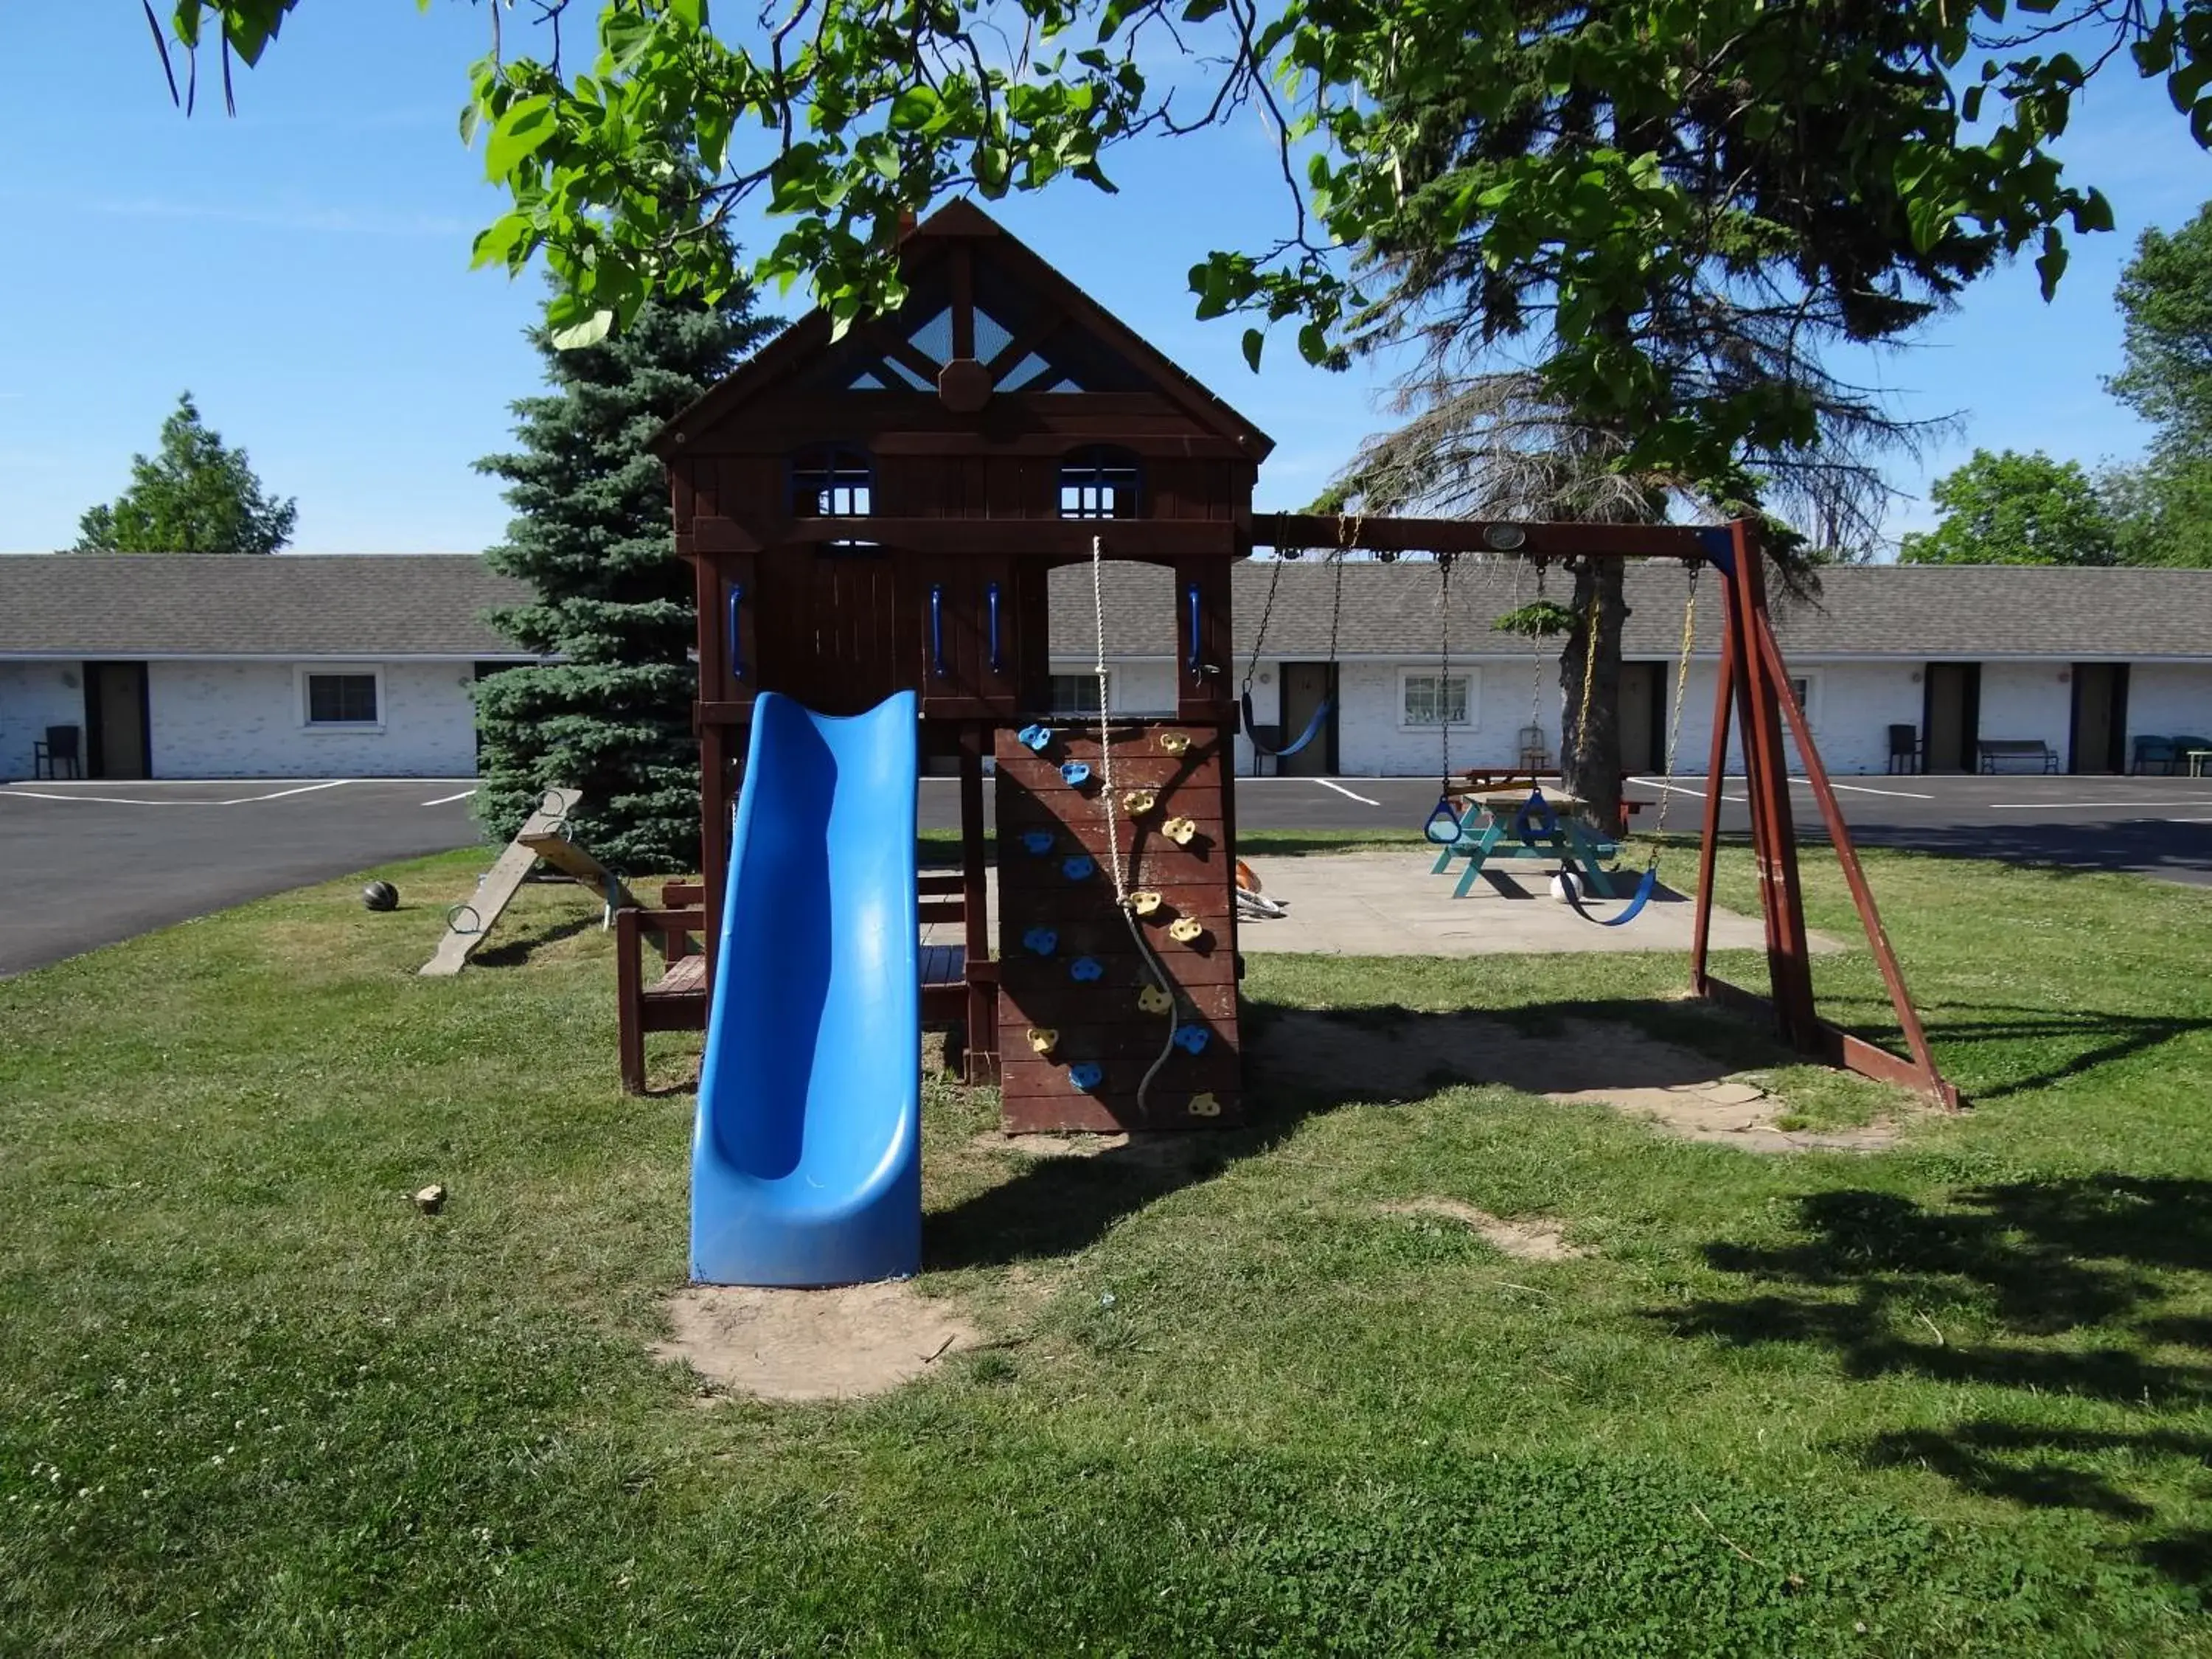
[615,869,998,1095]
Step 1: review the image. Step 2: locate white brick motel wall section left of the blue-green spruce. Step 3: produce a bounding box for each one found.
[0,659,476,779]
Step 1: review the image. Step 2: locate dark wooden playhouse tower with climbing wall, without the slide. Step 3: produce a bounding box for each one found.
[655,201,1272,1130]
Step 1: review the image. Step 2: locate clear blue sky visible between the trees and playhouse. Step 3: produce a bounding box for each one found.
[0,0,2212,553]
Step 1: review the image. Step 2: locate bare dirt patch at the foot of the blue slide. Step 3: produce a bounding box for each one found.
[653,1283,982,1400]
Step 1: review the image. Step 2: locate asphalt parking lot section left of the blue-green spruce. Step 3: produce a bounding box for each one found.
[0,779,478,978]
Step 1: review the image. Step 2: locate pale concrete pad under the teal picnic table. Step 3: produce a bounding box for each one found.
[1239,847,1845,956]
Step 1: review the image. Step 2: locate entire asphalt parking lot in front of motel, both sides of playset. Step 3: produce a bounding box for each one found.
[0,776,2212,978]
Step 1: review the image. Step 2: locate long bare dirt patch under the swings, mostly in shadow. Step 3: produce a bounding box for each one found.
[1248,1009,1898,1152]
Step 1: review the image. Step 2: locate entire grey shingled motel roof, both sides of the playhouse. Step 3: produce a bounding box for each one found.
[0,553,2212,661]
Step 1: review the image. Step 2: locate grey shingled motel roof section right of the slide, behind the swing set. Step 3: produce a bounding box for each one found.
[1053,560,2212,661]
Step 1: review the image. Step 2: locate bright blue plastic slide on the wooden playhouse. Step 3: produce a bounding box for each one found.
[692,692,922,1285]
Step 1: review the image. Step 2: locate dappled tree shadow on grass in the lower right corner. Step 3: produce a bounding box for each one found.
[1648,1175,2212,1604]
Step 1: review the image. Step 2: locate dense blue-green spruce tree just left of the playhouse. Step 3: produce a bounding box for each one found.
[476,290,774,872]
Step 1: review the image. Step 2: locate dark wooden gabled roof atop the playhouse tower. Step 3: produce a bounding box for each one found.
[653,199,1274,462]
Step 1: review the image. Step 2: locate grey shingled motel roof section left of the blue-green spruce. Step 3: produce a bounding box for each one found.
[0,553,531,659]
